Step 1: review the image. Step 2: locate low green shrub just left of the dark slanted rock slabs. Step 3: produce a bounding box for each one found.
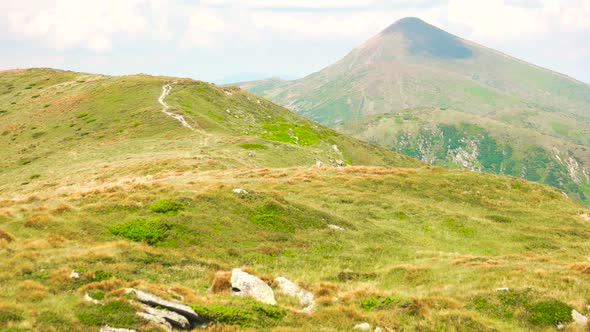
[78,301,139,327]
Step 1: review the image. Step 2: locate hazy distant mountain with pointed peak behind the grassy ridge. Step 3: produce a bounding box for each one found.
[238,18,590,204]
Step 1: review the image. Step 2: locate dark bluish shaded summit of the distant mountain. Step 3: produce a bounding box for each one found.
[382,17,473,59]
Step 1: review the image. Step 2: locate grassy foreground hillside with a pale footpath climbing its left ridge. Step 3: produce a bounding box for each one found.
[0,69,590,331]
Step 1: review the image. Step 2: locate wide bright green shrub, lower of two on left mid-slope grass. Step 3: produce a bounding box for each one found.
[109,218,166,245]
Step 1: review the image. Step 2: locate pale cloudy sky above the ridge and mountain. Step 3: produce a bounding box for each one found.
[0,0,590,83]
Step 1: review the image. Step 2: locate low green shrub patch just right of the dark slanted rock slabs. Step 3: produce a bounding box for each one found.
[191,300,287,328]
